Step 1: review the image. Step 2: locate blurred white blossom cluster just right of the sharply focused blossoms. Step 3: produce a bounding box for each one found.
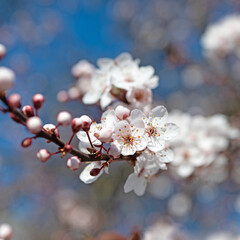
[169,111,240,178]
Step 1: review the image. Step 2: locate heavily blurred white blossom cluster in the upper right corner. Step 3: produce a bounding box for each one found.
[201,14,240,57]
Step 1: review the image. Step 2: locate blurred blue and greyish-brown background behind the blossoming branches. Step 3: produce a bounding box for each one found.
[0,0,240,240]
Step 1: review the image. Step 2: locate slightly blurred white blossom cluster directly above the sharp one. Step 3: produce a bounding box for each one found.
[79,53,158,109]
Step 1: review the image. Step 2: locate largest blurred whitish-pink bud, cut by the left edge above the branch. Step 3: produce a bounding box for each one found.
[0,67,15,91]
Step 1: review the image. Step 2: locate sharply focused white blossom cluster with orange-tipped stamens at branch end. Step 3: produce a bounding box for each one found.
[77,106,178,196]
